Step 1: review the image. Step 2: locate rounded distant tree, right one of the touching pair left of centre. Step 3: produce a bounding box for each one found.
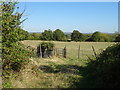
[53,29,66,41]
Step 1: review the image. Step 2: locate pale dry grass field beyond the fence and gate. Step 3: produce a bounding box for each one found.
[22,40,114,60]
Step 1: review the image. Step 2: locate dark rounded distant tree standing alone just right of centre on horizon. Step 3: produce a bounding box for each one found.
[71,30,85,41]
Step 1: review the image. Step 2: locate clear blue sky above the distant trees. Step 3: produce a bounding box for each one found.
[18,2,118,33]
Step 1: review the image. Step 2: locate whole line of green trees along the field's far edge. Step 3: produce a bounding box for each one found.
[21,29,120,42]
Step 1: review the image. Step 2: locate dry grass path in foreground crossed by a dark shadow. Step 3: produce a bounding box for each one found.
[12,57,85,88]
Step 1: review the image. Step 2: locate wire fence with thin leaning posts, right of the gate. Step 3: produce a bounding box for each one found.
[57,45,101,59]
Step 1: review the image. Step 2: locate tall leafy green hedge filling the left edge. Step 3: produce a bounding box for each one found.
[0,2,34,87]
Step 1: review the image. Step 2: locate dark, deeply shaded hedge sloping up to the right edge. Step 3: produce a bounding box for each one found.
[72,44,120,88]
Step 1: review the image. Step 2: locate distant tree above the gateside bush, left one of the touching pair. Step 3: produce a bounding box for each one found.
[42,29,53,41]
